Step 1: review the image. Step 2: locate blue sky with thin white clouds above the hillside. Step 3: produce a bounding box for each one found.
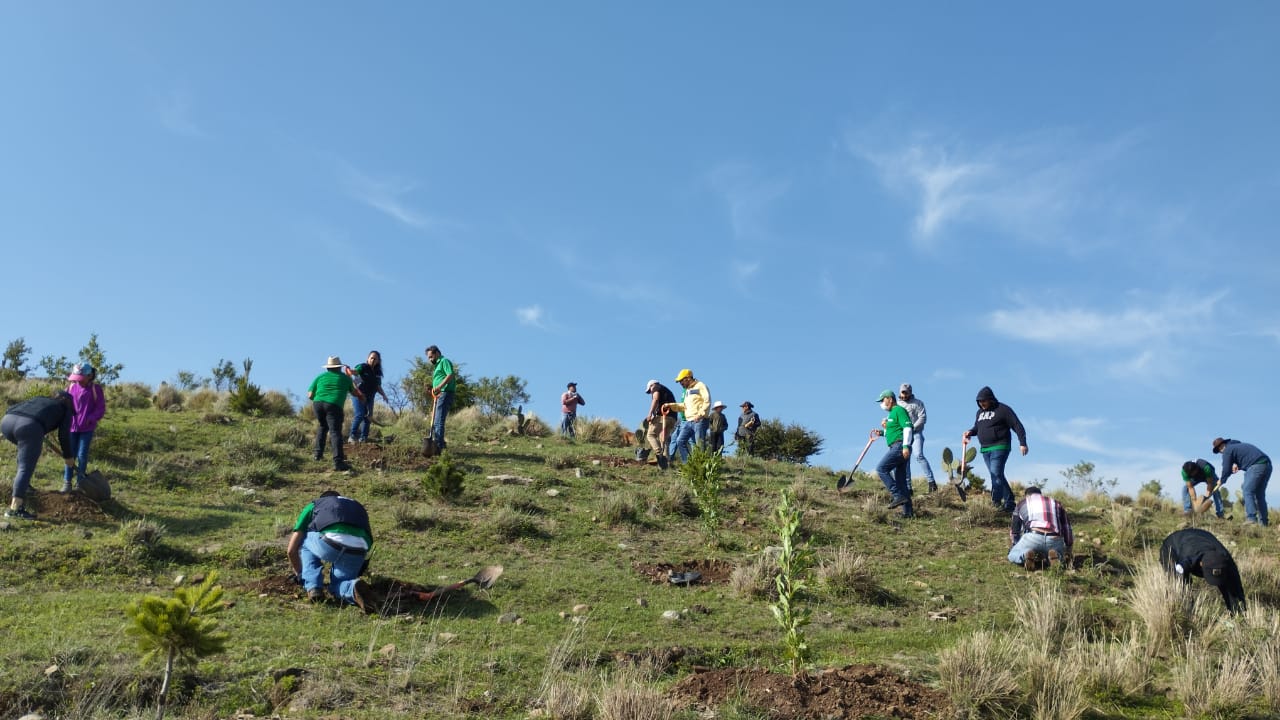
[0,3,1280,503]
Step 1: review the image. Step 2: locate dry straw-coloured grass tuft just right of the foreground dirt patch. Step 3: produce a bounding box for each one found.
[938,630,1021,717]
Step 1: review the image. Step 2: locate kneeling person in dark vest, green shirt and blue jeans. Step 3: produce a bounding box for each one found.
[285,489,376,612]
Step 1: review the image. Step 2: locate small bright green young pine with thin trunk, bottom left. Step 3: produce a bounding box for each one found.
[124,573,228,720]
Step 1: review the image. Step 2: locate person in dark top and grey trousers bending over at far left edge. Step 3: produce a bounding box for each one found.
[0,391,76,520]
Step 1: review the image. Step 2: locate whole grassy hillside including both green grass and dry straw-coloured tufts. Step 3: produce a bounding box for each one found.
[0,392,1280,717]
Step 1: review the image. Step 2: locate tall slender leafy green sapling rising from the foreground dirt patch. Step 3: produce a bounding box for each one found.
[769,489,813,678]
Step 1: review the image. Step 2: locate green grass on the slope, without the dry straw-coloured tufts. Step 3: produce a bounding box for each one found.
[0,399,1280,717]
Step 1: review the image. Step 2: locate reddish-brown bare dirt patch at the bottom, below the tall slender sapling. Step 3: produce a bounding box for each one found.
[671,665,951,720]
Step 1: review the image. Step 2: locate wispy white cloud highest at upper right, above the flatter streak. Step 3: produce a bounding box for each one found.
[846,128,1133,251]
